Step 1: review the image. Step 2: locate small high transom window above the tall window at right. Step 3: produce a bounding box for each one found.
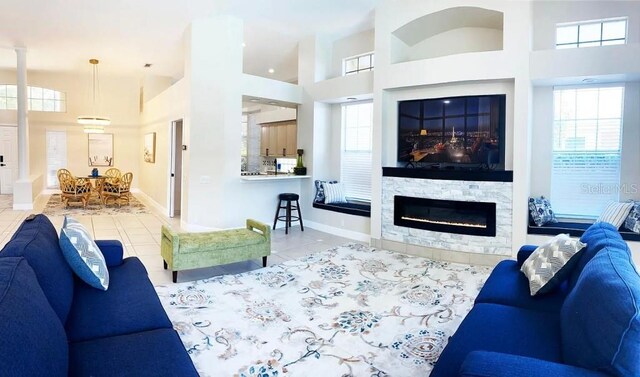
[556,18,627,49]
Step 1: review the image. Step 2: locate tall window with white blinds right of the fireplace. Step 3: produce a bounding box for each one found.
[551,86,624,218]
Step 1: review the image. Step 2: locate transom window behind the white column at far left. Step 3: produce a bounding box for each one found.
[0,84,67,113]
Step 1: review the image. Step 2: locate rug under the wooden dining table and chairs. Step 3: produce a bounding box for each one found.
[42,194,151,216]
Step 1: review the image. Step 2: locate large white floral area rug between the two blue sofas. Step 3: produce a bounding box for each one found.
[156,244,489,377]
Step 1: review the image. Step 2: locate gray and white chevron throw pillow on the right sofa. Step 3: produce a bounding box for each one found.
[520,234,587,296]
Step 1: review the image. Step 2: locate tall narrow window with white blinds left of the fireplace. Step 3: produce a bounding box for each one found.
[340,102,373,201]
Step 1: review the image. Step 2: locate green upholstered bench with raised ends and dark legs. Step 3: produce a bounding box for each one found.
[160,219,271,283]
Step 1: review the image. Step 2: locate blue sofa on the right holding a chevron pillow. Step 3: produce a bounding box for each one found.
[431,223,640,377]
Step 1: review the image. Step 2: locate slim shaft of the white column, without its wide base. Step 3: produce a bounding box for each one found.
[16,47,29,180]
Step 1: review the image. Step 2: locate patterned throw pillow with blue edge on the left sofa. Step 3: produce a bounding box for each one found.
[60,223,109,291]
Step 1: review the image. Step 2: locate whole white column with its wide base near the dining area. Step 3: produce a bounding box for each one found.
[13,47,34,210]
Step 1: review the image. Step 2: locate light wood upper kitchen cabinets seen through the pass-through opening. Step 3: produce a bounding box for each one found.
[260,121,298,157]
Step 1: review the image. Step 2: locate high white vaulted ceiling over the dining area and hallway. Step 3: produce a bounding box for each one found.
[0,0,378,81]
